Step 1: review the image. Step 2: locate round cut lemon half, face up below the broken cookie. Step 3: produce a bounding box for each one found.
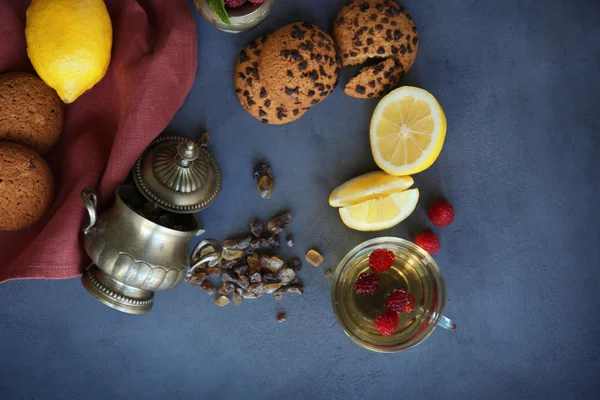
[371,86,446,176]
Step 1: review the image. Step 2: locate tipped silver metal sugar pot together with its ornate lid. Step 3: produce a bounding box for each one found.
[81,137,221,314]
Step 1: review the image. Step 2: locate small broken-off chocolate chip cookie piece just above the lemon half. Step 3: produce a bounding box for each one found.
[344,58,404,99]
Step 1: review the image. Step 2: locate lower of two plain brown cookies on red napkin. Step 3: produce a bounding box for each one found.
[0,142,54,231]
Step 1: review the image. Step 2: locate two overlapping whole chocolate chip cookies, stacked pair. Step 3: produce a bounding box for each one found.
[234,22,341,124]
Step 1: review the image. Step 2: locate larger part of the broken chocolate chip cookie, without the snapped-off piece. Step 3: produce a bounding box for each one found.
[333,0,419,72]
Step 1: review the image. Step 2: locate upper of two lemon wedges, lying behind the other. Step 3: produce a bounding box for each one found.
[329,171,414,207]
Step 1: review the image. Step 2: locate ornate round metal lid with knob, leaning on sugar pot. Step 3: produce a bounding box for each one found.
[133,133,221,214]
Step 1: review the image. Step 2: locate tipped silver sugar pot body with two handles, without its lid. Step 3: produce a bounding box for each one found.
[81,185,221,314]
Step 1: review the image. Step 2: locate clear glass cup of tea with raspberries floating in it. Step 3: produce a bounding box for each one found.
[331,237,456,353]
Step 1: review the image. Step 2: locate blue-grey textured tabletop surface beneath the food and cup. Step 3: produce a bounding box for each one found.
[0,0,600,399]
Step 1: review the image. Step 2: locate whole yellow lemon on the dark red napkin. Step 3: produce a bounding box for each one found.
[25,0,112,103]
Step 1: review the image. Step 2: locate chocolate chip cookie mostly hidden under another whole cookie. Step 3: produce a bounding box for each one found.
[234,36,306,125]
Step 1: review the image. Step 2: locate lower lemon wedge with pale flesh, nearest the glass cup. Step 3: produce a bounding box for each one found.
[340,189,419,231]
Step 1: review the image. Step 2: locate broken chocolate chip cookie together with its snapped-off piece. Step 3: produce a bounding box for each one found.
[333,0,419,98]
